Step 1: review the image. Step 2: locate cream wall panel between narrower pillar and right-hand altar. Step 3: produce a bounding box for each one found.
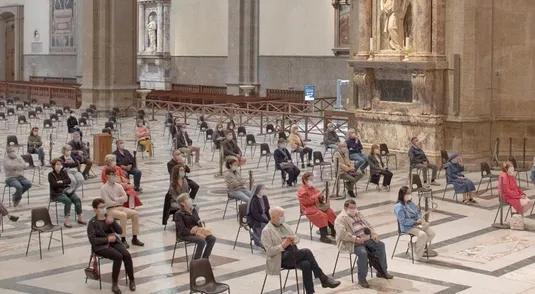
[260,0,334,56]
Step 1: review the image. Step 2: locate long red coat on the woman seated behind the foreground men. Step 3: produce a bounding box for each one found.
[297,185,336,228]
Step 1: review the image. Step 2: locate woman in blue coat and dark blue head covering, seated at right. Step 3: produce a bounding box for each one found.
[444,152,477,204]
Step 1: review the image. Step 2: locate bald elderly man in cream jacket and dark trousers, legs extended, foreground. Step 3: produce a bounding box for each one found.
[262,206,340,294]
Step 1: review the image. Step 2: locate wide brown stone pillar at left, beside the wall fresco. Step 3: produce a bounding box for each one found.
[80,0,137,111]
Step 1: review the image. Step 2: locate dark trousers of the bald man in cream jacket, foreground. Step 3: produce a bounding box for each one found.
[281,246,323,293]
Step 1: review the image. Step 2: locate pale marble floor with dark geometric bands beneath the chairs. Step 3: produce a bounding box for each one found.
[0,111,535,294]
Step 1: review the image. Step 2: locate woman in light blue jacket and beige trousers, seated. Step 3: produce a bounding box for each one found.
[394,186,437,261]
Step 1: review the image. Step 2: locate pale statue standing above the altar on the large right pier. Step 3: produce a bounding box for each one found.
[381,0,410,50]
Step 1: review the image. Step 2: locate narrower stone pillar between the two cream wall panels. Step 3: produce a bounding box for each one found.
[227,0,260,95]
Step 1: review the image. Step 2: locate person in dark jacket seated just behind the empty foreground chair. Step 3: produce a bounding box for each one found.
[173,193,216,259]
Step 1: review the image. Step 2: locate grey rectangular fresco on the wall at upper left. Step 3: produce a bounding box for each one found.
[50,0,76,53]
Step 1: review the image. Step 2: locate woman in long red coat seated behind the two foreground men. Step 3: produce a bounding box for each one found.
[297,172,336,244]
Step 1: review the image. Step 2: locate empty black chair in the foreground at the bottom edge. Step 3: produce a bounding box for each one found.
[189,258,230,294]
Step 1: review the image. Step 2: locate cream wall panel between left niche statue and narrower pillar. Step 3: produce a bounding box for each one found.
[172,0,228,56]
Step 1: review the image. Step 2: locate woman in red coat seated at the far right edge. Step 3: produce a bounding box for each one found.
[498,161,534,215]
